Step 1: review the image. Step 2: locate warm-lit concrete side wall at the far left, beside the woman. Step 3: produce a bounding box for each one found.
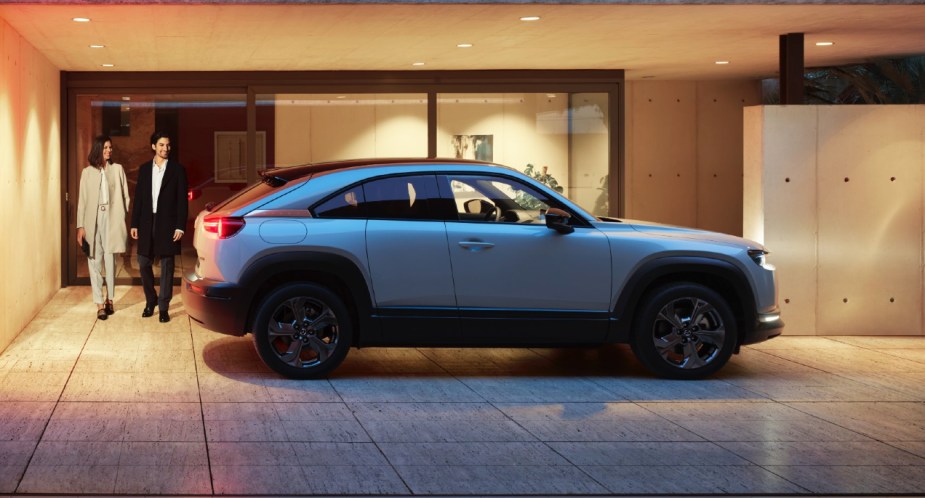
[0,19,61,350]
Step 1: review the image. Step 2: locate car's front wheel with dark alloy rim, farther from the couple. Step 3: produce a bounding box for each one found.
[631,283,738,379]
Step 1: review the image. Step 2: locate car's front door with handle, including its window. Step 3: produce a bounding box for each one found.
[440,174,611,344]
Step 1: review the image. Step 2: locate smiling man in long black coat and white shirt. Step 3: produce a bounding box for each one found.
[131,132,188,322]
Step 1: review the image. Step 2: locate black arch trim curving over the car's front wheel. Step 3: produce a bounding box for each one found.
[608,256,758,344]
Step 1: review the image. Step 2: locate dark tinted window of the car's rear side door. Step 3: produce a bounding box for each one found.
[363,175,443,220]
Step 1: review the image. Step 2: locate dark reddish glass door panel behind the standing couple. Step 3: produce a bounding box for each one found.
[67,93,251,284]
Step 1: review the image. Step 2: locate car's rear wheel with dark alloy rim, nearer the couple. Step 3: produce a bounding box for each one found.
[254,284,353,379]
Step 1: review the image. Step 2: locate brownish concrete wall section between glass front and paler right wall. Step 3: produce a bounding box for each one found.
[626,81,761,235]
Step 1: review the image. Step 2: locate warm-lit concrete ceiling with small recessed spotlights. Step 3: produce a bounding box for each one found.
[0,1,925,80]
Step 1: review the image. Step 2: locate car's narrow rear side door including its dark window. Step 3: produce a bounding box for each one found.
[363,175,456,344]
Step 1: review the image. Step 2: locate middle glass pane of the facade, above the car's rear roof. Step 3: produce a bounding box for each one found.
[257,94,427,167]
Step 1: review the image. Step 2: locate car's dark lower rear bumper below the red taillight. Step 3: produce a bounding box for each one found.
[180,273,248,336]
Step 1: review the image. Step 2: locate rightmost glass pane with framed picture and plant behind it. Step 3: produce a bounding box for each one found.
[437,93,610,215]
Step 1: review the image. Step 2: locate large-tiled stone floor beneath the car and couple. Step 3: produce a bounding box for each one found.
[0,287,925,496]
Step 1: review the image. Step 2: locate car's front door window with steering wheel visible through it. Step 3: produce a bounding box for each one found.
[446,175,550,224]
